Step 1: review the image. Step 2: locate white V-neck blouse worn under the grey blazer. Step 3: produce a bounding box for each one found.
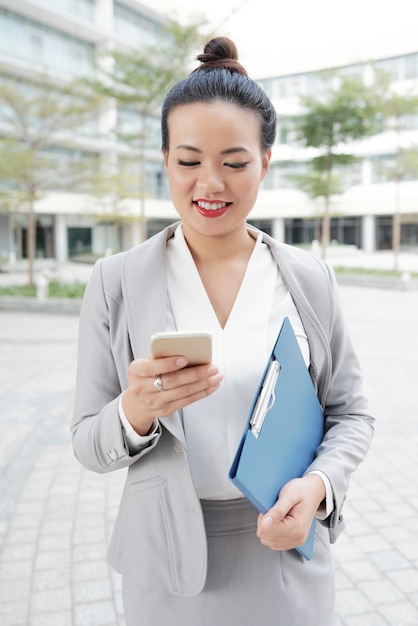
[166,226,309,500]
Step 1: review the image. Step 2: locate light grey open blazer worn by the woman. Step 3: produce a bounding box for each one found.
[71,224,373,596]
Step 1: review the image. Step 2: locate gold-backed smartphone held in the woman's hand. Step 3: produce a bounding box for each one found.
[151,331,212,367]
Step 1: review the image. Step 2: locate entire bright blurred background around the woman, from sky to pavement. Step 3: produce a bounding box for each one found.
[0,0,418,626]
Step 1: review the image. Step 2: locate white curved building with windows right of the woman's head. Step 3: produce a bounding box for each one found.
[253,52,418,252]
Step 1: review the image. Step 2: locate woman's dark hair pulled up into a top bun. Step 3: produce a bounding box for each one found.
[161,37,276,150]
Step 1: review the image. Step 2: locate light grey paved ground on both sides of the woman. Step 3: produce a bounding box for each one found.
[0,287,418,626]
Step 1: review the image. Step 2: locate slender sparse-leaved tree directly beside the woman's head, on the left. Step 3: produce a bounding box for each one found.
[83,18,204,241]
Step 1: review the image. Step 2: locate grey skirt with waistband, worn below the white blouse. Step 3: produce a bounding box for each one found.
[122,499,334,626]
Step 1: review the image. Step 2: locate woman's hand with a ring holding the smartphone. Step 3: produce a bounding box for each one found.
[122,356,223,435]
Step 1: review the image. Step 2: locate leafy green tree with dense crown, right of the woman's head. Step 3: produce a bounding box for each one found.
[296,77,377,258]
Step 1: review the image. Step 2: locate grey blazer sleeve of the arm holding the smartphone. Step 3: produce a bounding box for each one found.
[71,261,161,473]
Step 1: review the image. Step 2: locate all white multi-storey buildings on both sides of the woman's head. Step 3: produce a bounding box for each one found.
[0,0,418,262]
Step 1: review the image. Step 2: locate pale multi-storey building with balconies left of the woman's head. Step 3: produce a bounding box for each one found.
[0,0,168,262]
